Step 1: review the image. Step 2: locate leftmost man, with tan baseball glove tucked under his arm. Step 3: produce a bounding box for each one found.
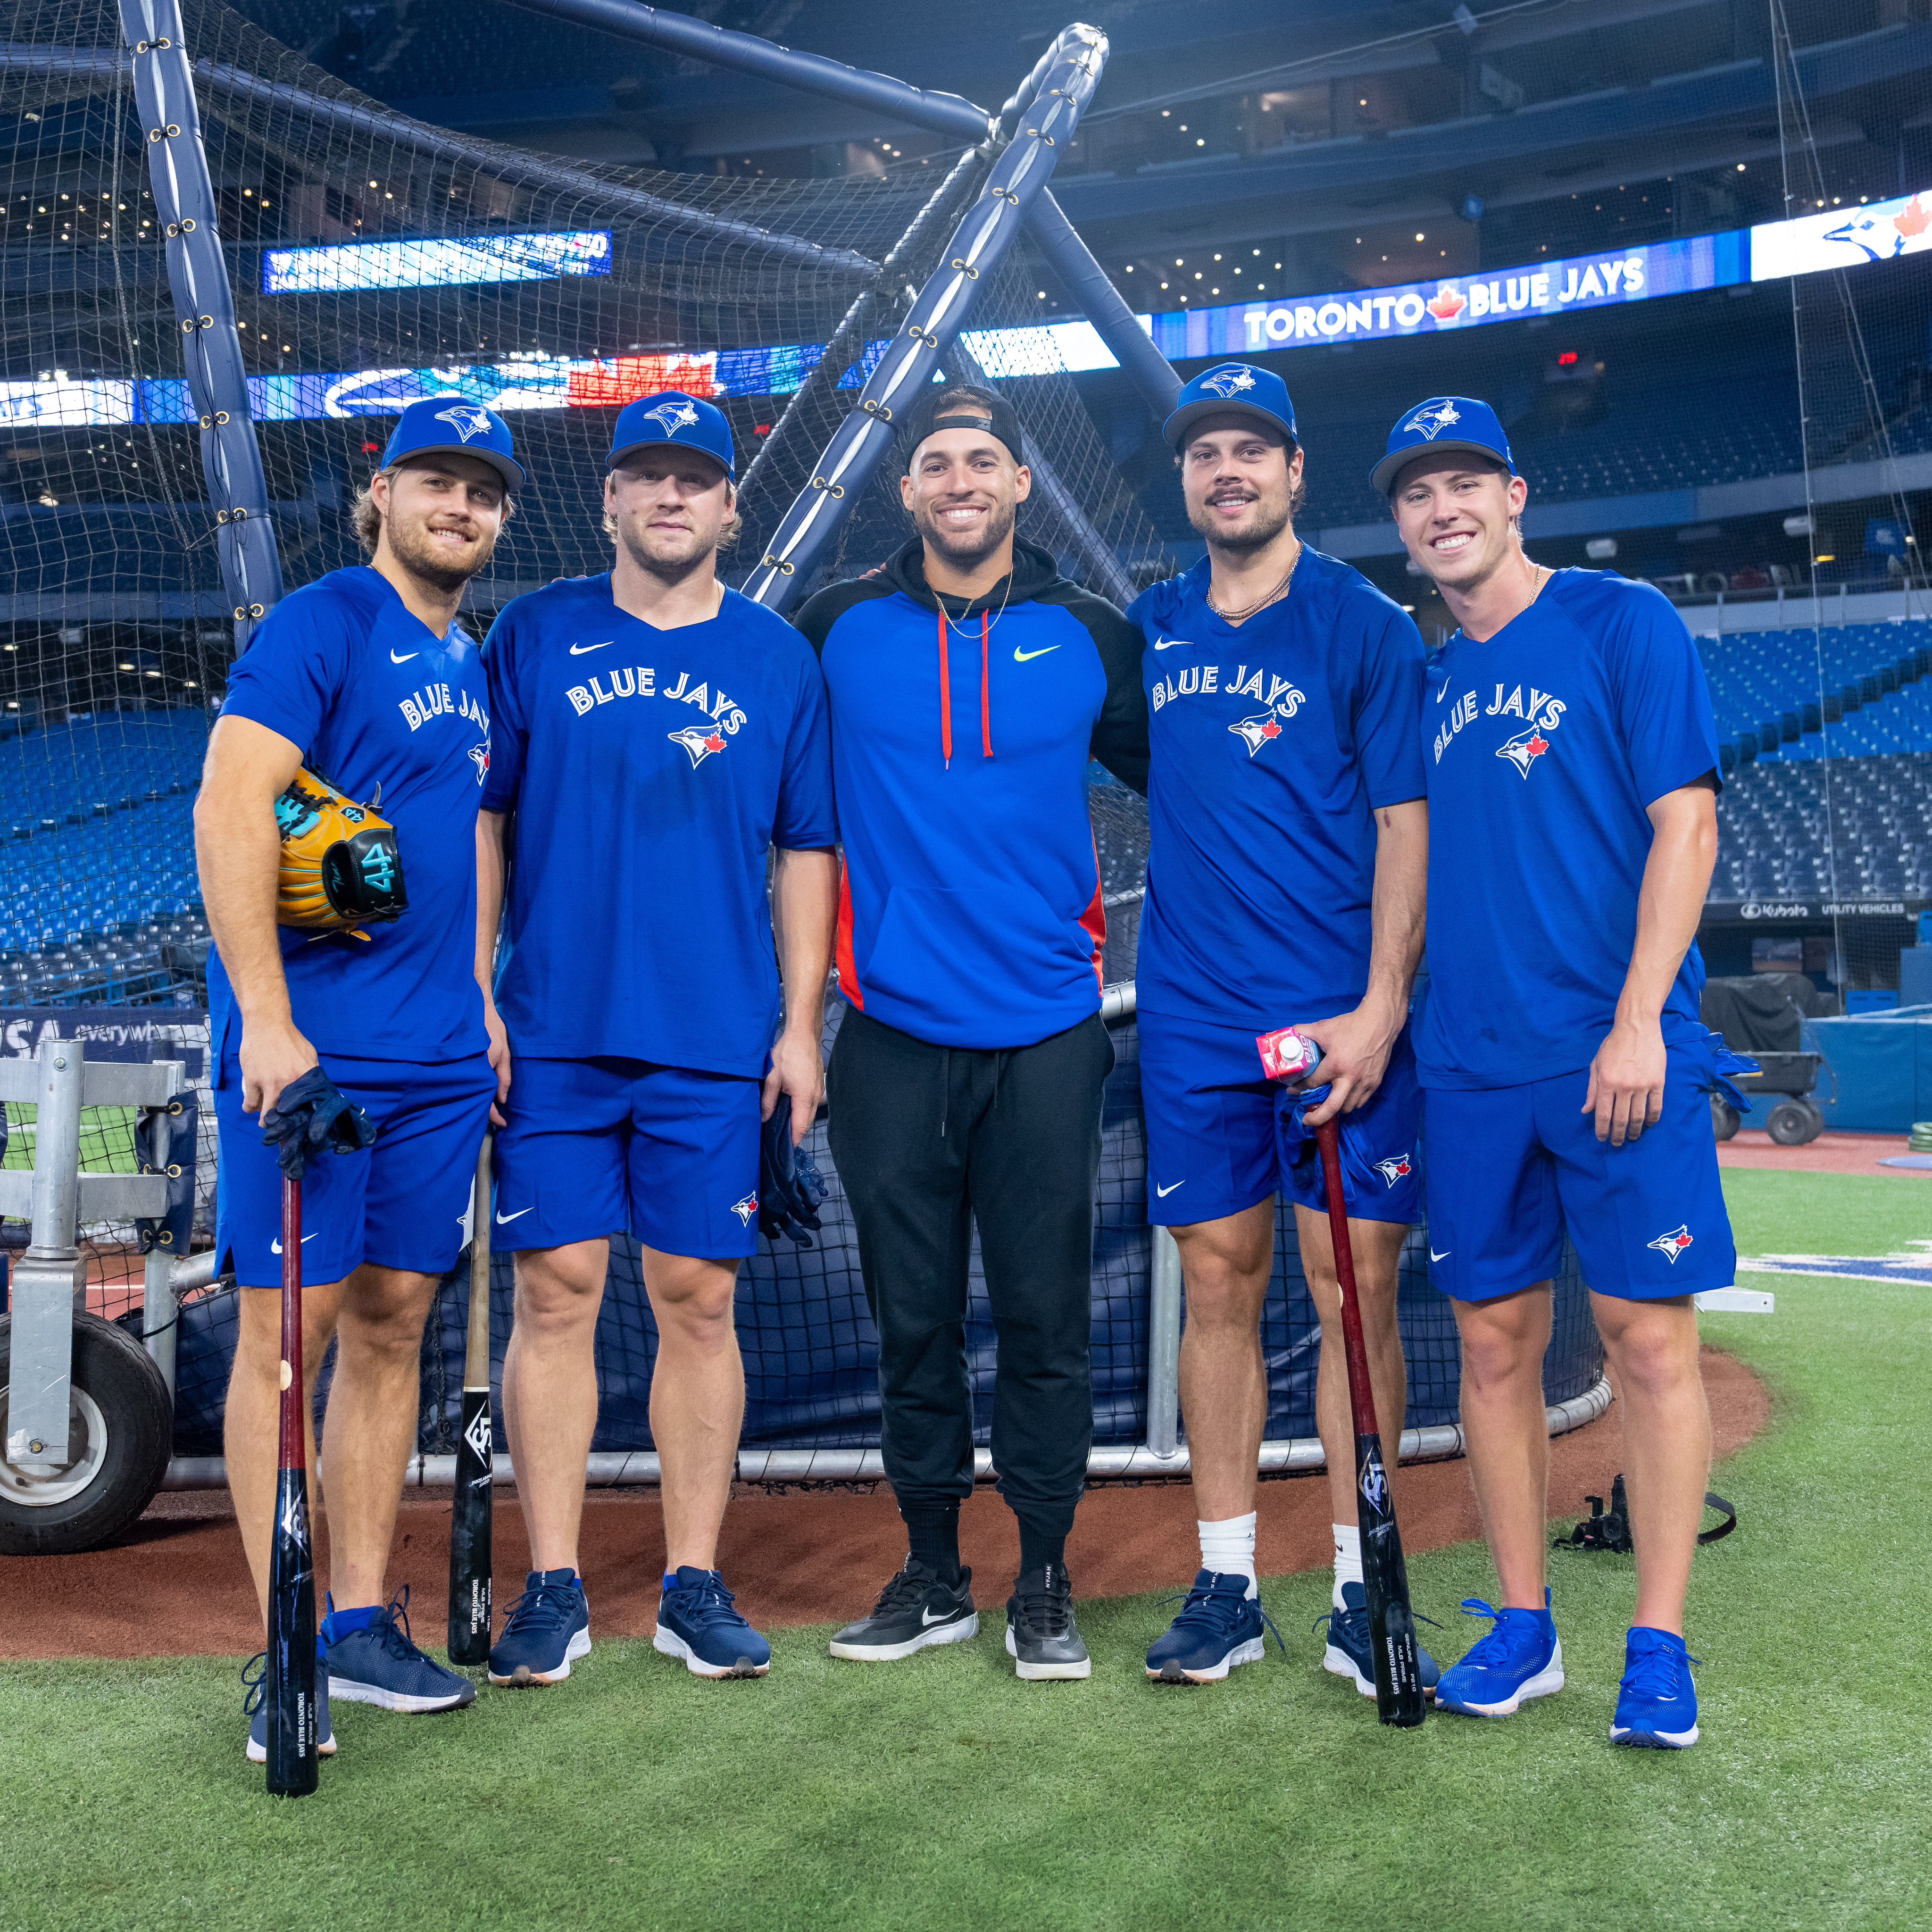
[195,396,524,1762]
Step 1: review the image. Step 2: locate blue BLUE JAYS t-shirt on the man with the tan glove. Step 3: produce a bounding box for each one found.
[208,566,491,1065]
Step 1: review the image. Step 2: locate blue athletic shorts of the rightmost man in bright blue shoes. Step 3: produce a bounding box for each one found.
[1424,1041,1737,1302]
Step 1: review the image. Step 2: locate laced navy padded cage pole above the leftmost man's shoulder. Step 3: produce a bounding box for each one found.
[120,0,282,655]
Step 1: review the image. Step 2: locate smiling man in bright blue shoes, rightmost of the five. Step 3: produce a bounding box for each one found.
[1370,396,1737,1749]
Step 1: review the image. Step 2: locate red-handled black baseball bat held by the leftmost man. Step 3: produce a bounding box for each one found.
[268,1179,321,1799]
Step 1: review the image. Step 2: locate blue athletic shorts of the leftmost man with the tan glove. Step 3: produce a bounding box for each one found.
[215,1051,497,1289]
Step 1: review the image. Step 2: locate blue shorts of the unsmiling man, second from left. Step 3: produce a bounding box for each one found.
[491,1059,761,1262]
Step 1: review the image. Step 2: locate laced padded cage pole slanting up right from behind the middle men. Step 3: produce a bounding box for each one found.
[744,23,1107,615]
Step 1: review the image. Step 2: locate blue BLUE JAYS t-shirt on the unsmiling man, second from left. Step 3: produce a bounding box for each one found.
[483,574,839,1076]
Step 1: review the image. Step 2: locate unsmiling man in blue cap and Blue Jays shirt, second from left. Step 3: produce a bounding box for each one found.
[477,390,839,1683]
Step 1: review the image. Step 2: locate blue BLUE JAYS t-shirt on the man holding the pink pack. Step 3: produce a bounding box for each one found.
[1128,549,1424,1035]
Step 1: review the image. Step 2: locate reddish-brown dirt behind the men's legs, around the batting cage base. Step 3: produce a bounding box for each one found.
[0,1349,1770,1662]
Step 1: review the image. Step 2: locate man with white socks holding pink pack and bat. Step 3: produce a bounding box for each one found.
[1128,363,1433,1696]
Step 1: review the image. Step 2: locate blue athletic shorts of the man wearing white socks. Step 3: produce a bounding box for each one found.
[1140,1012,1422,1227]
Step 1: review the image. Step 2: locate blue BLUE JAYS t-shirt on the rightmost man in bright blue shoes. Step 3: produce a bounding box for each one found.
[1416,570,1717,1088]
